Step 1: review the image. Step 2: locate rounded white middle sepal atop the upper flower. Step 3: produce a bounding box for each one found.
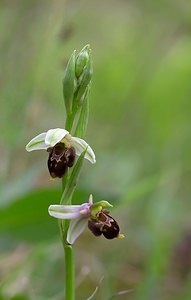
[45,128,69,147]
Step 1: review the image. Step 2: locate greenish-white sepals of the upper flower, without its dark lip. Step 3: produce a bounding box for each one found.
[26,128,96,164]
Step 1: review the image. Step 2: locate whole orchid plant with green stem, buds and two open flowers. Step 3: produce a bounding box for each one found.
[26,45,123,300]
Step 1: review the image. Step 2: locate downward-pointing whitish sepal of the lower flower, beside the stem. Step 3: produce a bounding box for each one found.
[67,217,88,244]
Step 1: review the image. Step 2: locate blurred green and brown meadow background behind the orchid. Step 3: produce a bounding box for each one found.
[0,0,191,300]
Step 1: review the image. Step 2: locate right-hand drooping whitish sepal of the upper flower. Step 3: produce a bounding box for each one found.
[70,137,96,164]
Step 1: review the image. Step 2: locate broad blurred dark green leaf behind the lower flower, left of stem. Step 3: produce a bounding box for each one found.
[0,189,87,245]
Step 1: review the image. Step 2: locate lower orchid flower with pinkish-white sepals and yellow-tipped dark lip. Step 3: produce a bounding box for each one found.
[48,195,124,244]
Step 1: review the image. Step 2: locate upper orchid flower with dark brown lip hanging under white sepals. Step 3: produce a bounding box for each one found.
[26,128,96,178]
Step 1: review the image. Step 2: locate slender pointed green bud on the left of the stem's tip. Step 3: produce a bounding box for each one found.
[63,51,76,114]
